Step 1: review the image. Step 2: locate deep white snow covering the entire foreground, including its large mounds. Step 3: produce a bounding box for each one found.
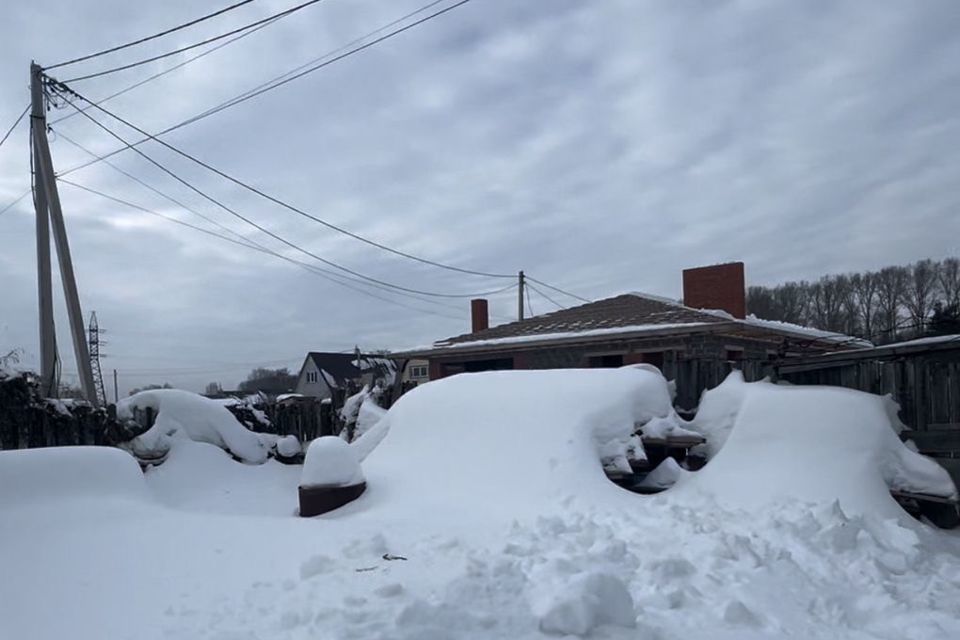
[0,368,960,640]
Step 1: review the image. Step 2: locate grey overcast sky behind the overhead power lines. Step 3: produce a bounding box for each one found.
[0,0,960,394]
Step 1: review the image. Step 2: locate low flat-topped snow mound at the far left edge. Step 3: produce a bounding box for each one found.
[0,447,148,509]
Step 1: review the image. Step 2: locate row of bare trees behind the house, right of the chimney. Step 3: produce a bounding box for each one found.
[747,258,960,343]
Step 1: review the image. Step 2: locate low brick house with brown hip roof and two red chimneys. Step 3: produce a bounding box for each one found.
[394,262,869,408]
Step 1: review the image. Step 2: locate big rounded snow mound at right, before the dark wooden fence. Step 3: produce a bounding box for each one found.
[678,379,957,517]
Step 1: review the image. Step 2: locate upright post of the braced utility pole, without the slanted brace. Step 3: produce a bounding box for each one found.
[30,64,60,397]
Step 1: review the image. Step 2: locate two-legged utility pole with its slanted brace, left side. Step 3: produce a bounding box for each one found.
[30,63,99,406]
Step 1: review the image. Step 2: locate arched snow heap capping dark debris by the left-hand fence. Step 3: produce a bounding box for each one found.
[117,389,268,464]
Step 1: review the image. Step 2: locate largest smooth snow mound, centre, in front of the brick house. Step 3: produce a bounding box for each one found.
[354,368,673,522]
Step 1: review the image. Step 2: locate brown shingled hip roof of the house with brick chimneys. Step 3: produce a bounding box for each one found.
[434,293,729,347]
